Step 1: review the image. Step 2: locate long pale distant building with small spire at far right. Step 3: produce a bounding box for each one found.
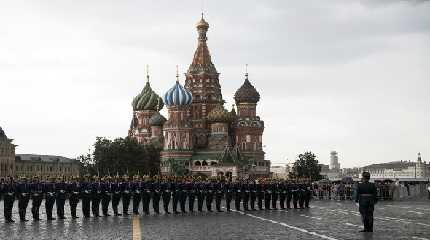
[362,153,430,179]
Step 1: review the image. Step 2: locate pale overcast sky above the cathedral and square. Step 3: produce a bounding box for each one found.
[0,0,430,167]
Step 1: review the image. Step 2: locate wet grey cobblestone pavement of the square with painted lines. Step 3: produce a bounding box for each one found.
[0,199,430,240]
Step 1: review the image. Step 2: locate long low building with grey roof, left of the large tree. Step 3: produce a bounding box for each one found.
[15,154,79,178]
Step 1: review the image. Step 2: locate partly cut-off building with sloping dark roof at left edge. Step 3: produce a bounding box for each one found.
[0,127,16,177]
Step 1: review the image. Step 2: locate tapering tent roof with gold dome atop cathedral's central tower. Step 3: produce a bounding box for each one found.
[188,13,217,74]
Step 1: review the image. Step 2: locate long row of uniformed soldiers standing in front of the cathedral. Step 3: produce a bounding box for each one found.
[0,176,312,222]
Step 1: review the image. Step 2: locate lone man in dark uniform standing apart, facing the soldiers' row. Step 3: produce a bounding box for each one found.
[355,172,378,232]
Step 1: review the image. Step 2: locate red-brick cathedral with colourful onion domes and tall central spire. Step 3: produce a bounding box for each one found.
[128,15,270,178]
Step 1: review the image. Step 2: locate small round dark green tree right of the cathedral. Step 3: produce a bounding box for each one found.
[290,152,322,181]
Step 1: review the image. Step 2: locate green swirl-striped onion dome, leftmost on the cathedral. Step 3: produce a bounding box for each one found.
[131,81,164,111]
